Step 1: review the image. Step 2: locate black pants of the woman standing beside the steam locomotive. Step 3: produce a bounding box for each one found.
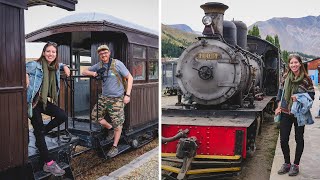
[280,113,304,165]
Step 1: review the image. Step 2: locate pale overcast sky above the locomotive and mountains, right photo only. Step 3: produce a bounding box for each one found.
[161,0,320,32]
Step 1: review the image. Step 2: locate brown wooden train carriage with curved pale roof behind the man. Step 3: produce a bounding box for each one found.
[26,13,159,145]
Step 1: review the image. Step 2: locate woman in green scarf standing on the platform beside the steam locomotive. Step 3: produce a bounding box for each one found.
[275,54,315,176]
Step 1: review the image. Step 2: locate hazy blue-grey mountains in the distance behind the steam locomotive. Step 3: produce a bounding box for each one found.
[162,16,320,56]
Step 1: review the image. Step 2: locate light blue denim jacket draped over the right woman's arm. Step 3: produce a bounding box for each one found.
[291,93,314,126]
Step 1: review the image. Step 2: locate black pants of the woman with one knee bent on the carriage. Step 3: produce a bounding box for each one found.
[31,101,68,162]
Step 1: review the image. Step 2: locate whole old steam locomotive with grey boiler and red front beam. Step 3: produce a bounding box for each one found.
[161,2,281,179]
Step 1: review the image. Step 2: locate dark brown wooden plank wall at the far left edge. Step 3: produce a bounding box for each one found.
[0,3,28,171]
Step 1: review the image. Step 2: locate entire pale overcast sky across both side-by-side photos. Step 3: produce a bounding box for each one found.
[25,0,320,57]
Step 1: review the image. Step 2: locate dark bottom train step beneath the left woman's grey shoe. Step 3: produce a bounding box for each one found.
[34,162,73,180]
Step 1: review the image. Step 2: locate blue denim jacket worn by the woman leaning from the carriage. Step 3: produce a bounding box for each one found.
[26,61,64,104]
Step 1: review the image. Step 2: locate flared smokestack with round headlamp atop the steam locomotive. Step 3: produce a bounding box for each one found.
[200,2,229,36]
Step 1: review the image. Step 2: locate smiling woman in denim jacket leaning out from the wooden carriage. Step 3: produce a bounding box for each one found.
[26,42,70,176]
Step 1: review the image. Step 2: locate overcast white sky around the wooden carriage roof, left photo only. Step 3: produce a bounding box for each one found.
[25,0,160,58]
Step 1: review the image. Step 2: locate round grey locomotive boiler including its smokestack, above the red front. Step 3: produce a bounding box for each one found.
[176,3,264,106]
